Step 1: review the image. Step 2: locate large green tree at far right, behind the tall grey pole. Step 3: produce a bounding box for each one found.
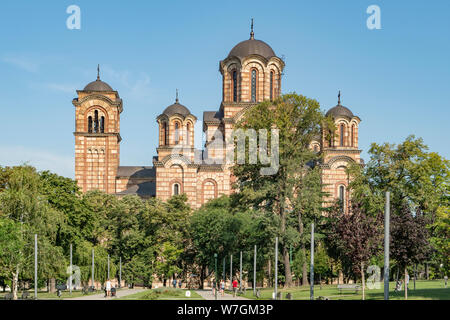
[349,135,450,288]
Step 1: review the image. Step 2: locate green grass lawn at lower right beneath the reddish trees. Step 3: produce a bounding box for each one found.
[239,280,450,300]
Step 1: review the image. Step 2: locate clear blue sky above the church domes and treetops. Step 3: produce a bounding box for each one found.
[0,0,450,177]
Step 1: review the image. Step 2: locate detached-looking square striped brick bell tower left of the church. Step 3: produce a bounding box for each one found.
[72,67,123,193]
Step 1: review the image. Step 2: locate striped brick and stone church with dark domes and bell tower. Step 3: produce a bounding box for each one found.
[72,28,362,209]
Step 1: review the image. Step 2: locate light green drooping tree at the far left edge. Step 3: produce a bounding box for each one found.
[0,165,65,299]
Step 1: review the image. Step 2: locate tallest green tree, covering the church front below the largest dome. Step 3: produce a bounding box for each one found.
[233,94,328,287]
